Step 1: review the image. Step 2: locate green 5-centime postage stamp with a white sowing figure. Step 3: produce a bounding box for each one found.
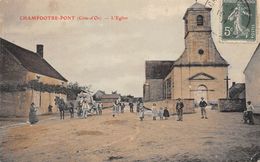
[221,0,257,41]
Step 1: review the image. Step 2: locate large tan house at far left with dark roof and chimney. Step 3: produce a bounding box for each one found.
[0,38,67,116]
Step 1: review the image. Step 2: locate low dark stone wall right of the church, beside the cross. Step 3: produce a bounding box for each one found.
[218,99,246,112]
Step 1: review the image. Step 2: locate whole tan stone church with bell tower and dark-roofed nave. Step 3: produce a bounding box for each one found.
[143,2,229,104]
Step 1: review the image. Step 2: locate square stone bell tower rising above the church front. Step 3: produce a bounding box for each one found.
[183,3,215,63]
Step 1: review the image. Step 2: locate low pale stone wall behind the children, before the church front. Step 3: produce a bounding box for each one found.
[144,99,195,114]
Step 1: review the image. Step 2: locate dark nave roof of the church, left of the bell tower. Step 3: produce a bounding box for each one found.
[145,61,174,79]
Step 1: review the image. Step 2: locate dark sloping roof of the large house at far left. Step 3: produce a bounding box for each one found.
[0,38,67,81]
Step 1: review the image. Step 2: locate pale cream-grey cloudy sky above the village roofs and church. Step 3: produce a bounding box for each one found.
[0,0,260,96]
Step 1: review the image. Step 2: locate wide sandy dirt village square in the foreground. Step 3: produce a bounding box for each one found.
[0,106,260,162]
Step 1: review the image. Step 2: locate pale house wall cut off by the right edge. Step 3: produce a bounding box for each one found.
[244,43,260,114]
